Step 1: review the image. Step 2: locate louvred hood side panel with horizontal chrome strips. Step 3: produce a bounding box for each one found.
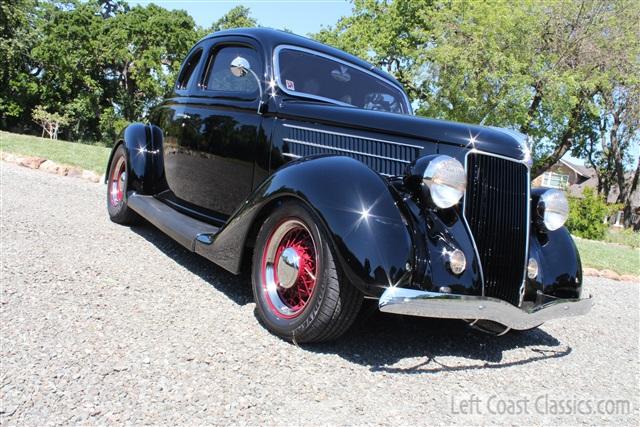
[283,125,422,176]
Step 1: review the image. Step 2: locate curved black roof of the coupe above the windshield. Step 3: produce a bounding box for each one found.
[201,27,404,89]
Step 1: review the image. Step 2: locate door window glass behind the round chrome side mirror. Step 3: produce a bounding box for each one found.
[202,46,262,98]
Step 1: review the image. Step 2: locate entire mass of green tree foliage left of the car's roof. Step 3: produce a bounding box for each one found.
[0,0,256,145]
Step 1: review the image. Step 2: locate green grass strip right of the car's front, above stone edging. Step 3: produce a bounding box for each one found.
[574,237,640,276]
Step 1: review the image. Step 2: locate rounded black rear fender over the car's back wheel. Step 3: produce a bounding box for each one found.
[105,123,167,195]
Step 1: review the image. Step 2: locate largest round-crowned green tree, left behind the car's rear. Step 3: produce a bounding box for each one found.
[18,0,198,141]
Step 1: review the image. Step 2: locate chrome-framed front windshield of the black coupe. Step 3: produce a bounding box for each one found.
[275,47,409,114]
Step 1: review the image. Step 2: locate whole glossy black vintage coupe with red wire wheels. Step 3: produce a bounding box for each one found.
[106,29,592,342]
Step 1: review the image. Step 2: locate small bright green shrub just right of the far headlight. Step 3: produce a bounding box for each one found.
[567,187,618,240]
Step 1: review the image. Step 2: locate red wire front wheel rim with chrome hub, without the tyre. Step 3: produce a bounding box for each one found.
[261,218,318,319]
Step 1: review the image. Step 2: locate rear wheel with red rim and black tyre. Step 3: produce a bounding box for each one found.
[107,145,140,225]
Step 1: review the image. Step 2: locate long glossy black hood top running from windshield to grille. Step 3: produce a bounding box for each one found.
[280,101,530,162]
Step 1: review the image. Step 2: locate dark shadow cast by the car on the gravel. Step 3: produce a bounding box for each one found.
[131,224,572,374]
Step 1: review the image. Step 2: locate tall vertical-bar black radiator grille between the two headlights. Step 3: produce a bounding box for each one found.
[464,153,529,305]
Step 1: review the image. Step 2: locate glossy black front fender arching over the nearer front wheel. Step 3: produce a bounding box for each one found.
[196,156,414,295]
